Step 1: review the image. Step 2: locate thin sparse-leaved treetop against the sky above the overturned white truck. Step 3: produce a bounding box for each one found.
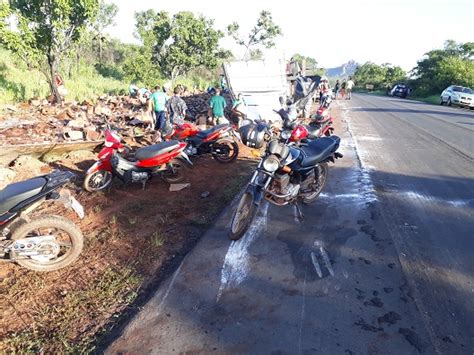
[227,10,282,59]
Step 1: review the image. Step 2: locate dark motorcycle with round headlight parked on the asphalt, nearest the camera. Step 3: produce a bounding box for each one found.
[229,136,342,240]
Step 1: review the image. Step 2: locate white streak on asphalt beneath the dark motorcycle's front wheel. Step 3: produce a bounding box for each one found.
[216,202,268,302]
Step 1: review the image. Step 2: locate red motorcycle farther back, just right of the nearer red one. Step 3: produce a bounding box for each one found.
[165,122,240,163]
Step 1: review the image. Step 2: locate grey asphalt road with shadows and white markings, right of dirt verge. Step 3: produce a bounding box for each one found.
[107,95,474,354]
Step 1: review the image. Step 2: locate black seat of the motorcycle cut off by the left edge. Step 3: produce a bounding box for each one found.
[0,177,47,215]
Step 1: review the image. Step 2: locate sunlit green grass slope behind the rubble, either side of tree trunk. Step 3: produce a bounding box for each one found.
[0,49,129,104]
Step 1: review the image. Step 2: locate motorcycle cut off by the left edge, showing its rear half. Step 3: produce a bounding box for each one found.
[0,171,84,271]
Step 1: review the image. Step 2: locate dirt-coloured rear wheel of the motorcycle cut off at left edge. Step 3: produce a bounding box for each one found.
[12,216,84,271]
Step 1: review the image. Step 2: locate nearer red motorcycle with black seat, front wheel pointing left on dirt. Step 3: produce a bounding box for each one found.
[84,130,192,192]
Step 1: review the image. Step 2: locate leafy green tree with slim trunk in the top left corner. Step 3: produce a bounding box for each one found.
[0,0,99,103]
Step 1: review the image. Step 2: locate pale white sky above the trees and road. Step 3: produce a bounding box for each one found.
[107,0,474,70]
